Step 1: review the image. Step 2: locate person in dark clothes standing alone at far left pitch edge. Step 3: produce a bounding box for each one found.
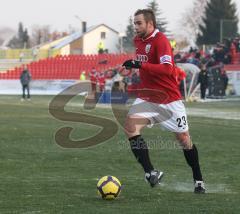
[20,65,31,101]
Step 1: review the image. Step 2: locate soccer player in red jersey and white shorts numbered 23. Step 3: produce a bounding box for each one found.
[123,9,205,193]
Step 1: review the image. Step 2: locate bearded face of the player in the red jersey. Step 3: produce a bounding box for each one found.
[134,14,152,38]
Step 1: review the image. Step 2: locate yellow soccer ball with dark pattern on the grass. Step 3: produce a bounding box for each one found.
[97,175,121,200]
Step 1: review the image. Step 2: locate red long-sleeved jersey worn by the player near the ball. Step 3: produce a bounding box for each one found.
[134,29,181,104]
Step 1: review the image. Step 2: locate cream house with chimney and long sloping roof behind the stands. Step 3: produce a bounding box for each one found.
[40,24,120,55]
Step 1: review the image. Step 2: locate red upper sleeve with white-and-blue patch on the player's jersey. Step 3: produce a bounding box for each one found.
[156,35,173,65]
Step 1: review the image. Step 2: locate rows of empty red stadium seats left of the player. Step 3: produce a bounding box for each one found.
[0,54,134,80]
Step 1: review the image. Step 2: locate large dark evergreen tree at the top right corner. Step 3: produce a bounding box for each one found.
[197,0,238,45]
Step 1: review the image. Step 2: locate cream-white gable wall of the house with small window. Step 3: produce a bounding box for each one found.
[83,25,120,54]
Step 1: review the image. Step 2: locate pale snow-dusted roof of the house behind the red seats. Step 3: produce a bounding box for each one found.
[52,24,119,49]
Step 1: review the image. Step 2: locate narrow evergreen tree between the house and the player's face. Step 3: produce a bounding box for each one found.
[123,17,135,52]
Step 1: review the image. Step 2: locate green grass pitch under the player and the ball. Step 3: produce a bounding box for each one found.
[0,96,240,214]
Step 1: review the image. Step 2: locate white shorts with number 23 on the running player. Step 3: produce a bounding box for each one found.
[128,98,188,133]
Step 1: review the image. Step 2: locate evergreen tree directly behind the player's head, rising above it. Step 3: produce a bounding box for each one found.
[147,0,167,33]
